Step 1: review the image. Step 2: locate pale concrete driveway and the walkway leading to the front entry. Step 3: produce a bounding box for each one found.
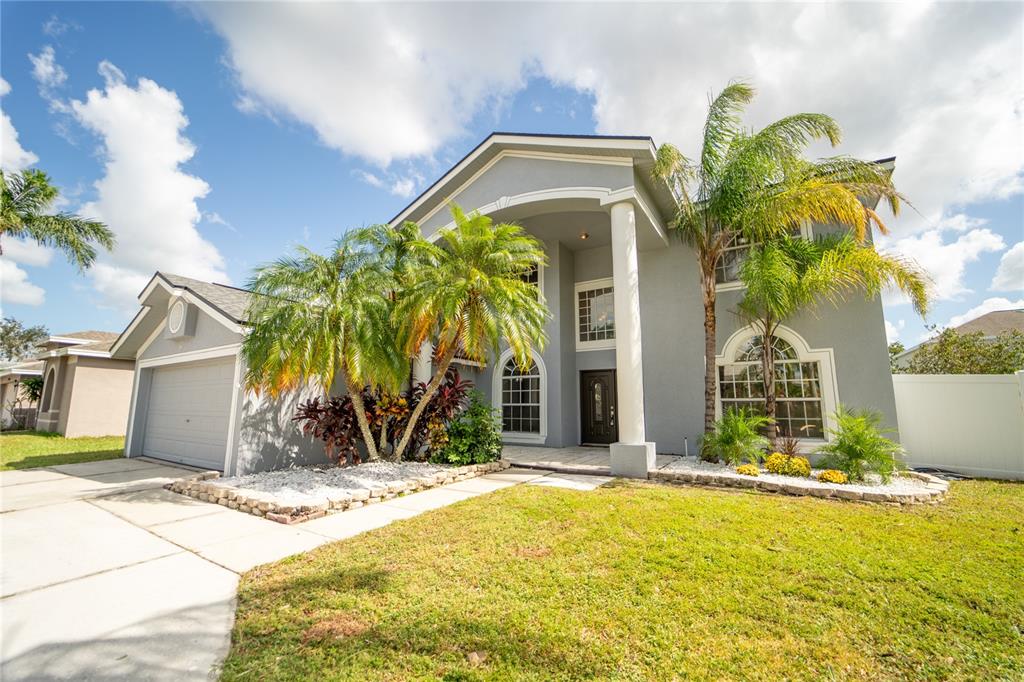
[0,460,609,682]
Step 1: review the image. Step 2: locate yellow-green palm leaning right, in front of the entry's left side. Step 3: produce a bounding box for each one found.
[395,205,550,458]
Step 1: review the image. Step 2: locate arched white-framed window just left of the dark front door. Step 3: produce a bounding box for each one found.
[492,350,548,443]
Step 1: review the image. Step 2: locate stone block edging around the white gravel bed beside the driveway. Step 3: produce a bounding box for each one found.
[164,460,512,524]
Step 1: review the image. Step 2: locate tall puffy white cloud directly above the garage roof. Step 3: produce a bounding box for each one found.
[71,61,228,310]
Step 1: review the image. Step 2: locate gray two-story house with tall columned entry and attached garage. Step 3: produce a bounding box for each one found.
[114,133,896,473]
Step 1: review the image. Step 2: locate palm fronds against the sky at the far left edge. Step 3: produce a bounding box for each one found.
[0,170,114,269]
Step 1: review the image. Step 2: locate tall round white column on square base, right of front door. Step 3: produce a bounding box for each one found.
[611,202,654,478]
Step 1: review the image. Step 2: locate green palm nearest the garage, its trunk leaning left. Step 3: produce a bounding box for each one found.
[242,232,406,460]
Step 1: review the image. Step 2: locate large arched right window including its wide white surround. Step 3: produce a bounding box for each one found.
[716,327,839,440]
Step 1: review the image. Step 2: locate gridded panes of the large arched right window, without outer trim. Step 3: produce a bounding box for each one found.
[718,336,824,438]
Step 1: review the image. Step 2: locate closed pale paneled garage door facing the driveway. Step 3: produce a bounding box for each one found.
[142,355,234,470]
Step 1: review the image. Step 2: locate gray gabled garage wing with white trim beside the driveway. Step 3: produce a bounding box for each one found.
[111,272,329,476]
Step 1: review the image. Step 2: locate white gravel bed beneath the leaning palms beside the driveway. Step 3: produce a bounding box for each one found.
[209,462,450,506]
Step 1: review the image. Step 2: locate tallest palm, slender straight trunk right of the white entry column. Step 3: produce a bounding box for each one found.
[653,83,901,433]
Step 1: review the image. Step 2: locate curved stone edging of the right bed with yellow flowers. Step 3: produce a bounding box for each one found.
[649,470,949,505]
